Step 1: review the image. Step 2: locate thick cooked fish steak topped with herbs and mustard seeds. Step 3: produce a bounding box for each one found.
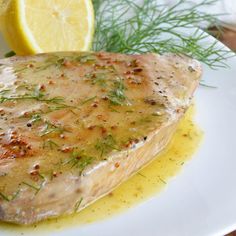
[0,52,201,224]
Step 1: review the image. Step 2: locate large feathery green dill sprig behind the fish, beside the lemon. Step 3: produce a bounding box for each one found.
[93,0,235,69]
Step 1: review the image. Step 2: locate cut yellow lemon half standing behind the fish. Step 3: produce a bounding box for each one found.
[1,0,94,55]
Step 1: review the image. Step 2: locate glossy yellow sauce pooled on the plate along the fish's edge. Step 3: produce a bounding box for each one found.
[0,107,203,235]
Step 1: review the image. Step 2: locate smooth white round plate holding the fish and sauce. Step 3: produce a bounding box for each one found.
[0,32,236,236]
